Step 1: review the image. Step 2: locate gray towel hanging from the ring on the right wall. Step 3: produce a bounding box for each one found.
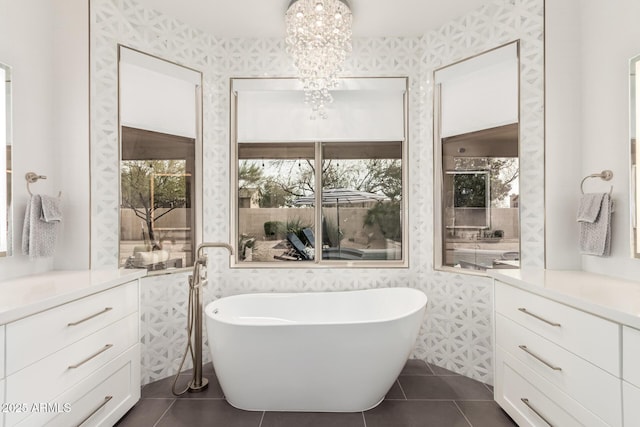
[577,193,613,256]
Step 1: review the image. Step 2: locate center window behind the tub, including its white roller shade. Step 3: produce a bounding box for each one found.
[232,79,407,267]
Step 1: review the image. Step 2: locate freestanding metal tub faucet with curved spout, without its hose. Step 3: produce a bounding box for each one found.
[189,242,233,393]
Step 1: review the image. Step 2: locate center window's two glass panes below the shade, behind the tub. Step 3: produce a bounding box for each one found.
[237,142,403,263]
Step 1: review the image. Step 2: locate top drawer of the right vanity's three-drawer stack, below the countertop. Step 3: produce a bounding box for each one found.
[495,281,621,377]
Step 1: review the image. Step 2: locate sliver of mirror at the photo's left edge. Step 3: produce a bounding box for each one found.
[0,63,12,257]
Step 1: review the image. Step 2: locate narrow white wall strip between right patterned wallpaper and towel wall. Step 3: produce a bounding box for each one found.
[545,0,582,270]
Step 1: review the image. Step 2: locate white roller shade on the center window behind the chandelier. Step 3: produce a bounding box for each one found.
[233,78,406,142]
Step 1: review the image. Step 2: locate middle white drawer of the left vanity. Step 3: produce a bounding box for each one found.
[6,313,138,425]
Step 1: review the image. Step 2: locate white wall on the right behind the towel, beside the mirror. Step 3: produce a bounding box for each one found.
[581,0,640,280]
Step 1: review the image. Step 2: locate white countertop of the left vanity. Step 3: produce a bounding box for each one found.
[0,269,147,325]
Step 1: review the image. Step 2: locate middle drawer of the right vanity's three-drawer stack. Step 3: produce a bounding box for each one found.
[496,314,622,426]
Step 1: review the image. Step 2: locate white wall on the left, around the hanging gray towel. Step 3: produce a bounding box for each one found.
[0,0,89,280]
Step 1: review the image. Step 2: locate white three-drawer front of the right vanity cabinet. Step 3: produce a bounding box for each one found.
[494,281,622,426]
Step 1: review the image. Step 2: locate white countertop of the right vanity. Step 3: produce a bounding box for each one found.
[488,269,640,329]
